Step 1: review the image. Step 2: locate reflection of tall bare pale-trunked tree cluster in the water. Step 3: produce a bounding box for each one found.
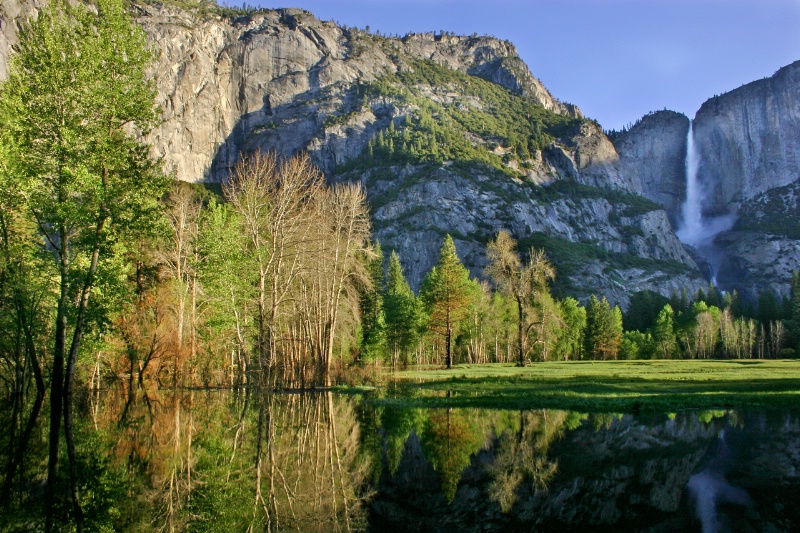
[248,392,370,531]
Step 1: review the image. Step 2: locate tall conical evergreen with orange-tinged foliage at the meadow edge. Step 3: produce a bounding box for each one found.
[420,235,473,368]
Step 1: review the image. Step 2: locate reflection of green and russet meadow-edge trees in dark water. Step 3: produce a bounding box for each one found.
[362,406,585,522]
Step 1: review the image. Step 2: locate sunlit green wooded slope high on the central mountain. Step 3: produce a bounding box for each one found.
[336,57,580,175]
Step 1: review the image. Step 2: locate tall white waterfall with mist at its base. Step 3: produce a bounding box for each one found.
[676,122,735,285]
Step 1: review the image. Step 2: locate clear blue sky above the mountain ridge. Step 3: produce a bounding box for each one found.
[255,0,800,129]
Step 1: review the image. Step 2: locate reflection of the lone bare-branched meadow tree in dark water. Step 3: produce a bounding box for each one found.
[488,410,567,513]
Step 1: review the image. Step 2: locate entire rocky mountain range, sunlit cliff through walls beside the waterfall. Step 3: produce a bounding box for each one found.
[26,0,800,305]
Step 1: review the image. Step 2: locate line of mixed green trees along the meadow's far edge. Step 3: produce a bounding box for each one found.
[359,231,800,368]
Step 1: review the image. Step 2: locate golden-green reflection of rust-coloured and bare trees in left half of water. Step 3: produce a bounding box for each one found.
[76,391,371,531]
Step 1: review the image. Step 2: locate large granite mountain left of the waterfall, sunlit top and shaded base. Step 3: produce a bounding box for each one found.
[128,5,704,305]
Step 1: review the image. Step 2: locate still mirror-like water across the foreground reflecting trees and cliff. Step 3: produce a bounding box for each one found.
[5,391,800,533]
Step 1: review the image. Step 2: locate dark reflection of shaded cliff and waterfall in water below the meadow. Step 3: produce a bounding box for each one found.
[369,411,800,532]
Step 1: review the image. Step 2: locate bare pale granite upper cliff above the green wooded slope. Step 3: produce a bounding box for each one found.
[137,6,577,181]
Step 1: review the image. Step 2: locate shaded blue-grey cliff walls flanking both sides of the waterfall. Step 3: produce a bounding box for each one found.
[614,62,800,300]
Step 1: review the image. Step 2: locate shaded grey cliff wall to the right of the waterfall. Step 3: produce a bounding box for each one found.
[695,62,800,297]
